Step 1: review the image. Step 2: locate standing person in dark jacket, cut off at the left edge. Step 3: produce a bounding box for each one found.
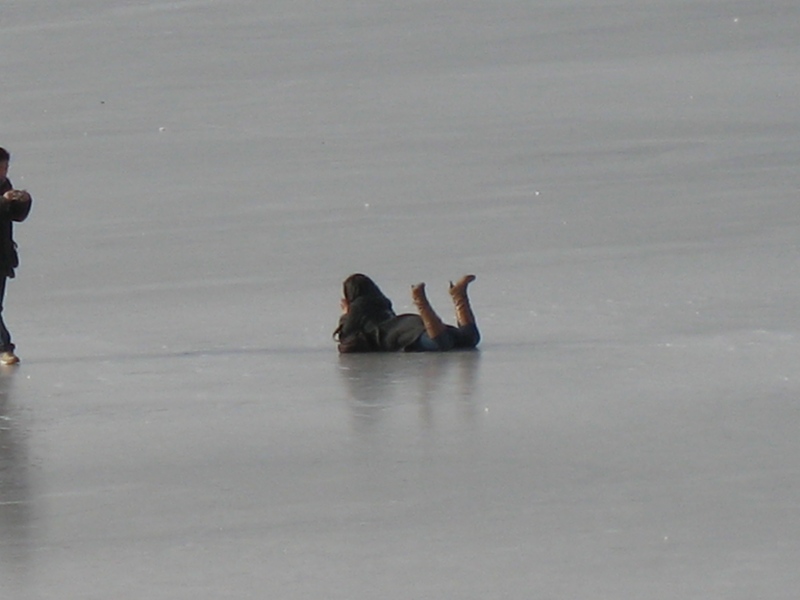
[0,148,32,365]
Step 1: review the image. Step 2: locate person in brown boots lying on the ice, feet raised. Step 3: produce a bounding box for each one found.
[333,273,481,354]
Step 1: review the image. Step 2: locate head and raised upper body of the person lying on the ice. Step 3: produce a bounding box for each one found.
[333,273,395,352]
